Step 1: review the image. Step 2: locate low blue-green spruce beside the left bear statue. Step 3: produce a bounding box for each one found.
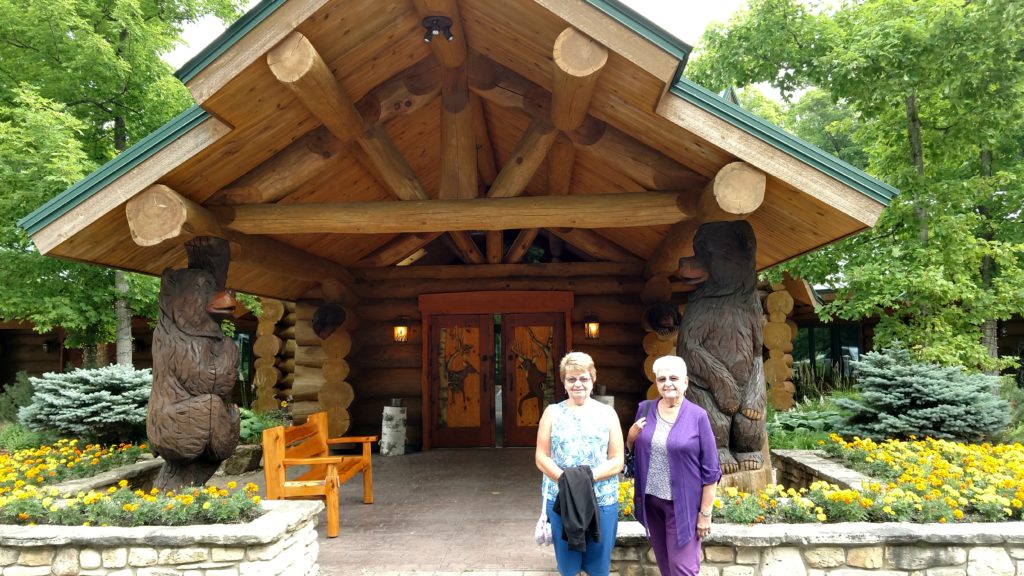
[18,365,153,443]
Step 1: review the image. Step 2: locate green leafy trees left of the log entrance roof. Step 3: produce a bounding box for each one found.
[0,0,241,346]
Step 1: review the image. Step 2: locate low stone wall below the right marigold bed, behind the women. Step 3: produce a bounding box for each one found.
[612,522,1024,576]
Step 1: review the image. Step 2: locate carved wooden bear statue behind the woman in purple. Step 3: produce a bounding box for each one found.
[677,220,767,474]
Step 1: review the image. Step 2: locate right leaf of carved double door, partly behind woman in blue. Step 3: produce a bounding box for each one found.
[502,313,565,446]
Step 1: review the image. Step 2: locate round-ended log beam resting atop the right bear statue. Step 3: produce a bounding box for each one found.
[644,162,766,278]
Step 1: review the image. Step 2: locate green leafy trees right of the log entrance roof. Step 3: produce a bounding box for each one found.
[687,0,1024,369]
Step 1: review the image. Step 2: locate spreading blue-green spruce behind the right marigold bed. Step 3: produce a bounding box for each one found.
[836,348,1010,442]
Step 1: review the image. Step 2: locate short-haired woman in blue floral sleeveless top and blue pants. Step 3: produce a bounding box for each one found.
[537,352,623,576]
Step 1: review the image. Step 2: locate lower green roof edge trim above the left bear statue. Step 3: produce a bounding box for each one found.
[17,106,210,236]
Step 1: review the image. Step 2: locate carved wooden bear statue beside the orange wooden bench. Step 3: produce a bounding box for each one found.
[146,239,239,490]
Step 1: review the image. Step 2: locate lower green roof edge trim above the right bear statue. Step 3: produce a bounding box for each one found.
[669,78,899,206]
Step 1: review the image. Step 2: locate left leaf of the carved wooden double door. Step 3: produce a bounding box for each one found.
[428,315,495,447]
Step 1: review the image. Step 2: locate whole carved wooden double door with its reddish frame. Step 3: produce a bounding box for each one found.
[424,289,569,448]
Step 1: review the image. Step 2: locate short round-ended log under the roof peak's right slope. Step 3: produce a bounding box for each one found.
[551,27,608,132]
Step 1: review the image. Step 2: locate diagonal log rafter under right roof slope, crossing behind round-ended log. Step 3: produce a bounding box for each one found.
[469,52,708,190]
